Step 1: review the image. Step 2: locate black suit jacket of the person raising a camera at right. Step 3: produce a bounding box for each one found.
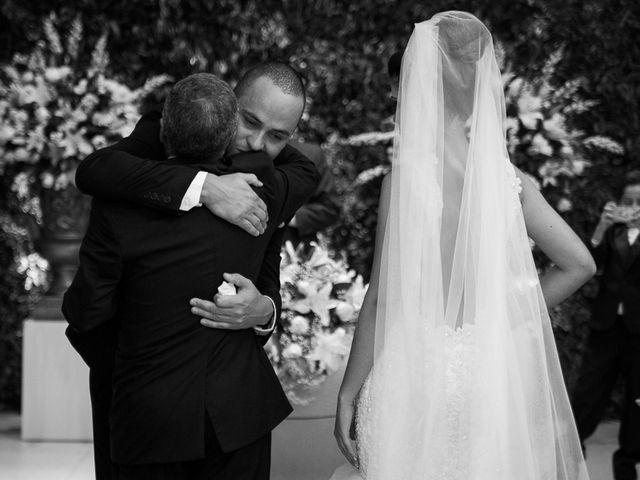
[591,224,640,334]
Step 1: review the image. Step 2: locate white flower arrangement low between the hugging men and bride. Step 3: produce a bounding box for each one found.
[265,242,366,405]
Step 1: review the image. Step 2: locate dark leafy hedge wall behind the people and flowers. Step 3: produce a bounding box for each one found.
[0,0,640,406]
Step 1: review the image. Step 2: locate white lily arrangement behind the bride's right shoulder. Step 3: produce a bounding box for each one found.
[503,49,624,212]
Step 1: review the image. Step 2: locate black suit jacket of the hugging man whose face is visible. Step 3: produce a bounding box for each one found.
[76,113,320,320]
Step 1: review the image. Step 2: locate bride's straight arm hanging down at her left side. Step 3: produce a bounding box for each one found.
[334,174,391,465]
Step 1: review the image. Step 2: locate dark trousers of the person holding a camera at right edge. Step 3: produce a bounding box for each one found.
[572,317,640,480]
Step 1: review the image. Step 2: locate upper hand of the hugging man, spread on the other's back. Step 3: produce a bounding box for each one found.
[200,173,269,237]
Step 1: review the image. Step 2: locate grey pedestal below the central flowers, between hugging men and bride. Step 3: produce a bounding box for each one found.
[271,369,347,480]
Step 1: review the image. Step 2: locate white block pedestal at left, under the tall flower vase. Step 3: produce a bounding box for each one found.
[22,319,92,441]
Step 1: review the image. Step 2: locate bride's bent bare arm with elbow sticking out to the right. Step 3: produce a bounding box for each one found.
[516,169,596,308]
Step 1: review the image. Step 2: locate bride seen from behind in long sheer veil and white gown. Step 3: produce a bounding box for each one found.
[333,12,595,480]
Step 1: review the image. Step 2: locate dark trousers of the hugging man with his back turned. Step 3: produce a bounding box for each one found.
[117,419,271,480]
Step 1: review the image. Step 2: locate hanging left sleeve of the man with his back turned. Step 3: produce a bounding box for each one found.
[62,202,123,368]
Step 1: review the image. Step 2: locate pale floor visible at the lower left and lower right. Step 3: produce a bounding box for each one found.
[0,413,618,480]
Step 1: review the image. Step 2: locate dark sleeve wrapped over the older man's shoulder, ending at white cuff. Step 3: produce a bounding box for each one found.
[76,115,198,213]
